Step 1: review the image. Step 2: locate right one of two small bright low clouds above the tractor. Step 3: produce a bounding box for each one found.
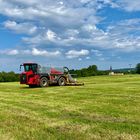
[66,49,89,59]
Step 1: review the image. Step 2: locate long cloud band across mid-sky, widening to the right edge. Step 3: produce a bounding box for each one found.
[23,19,140,52]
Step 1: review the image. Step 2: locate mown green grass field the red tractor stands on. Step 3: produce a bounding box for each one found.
[0,75,140,140]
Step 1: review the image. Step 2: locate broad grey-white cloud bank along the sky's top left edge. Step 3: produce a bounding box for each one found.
[0,0,97,26]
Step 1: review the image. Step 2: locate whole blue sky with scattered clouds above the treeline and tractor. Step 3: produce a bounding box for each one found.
[0,0,140,72]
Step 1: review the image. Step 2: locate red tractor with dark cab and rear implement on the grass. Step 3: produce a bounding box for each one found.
[20,63,83,87]
